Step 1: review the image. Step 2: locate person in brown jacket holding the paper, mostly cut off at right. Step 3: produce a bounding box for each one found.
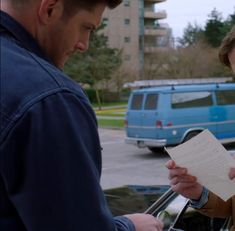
[166,27,235,231]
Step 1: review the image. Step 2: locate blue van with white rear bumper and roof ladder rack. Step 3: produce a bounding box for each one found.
[125,83,235,152]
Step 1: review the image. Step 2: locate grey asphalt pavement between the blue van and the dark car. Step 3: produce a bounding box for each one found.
[99,129,235,189]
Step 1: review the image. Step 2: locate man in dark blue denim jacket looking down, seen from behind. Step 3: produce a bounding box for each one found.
[0,0,162,231]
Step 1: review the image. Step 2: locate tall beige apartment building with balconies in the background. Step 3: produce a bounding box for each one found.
[103,0,171,79]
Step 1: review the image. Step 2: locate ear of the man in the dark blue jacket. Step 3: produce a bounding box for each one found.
[38,0,63,24]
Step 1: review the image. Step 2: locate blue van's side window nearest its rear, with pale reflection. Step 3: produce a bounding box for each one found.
[171,91,213,108]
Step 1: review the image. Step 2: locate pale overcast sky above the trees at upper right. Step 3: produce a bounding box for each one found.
[156,0,235,37]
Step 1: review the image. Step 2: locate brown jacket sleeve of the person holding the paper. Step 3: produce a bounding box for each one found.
[199,192,232,218]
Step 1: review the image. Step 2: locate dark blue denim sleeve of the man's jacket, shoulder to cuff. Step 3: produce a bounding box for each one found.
[0,92,134,231]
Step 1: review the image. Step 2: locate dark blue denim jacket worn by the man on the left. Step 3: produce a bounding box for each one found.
[0,12,134,231]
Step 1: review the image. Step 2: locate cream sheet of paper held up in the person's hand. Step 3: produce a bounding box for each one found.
[166,130,235,201]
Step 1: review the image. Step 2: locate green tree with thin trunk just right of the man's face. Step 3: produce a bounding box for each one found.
[65,26,122,108]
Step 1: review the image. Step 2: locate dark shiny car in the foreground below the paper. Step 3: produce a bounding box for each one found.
[104,185,231,231]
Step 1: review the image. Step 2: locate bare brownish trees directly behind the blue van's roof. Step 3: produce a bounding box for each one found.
[145,41,231,79]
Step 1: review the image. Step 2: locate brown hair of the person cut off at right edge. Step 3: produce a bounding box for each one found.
[219,26,235,67]
